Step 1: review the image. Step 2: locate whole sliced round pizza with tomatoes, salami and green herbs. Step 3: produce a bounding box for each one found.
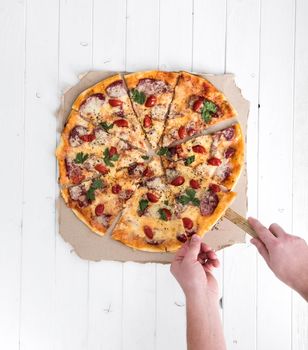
[56,71,244,252]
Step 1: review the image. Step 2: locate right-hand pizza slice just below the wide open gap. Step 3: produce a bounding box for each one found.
[158,124,244,190]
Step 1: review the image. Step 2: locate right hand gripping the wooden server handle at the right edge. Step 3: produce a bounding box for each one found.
[248,218,308,301]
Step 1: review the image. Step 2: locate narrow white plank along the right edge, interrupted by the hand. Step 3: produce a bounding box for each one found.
[292,0,308,350]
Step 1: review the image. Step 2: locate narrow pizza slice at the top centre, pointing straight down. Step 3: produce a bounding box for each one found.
[124,71,179,149]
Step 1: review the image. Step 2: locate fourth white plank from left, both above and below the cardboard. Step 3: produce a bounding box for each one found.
[88,0,126,350]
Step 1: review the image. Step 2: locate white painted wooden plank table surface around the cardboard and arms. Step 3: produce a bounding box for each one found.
[0,0,308,350]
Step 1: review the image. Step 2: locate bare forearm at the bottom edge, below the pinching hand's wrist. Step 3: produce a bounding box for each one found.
[186,294,226,350]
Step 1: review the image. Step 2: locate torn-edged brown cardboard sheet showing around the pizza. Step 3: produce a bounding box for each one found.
[58,71,249,263]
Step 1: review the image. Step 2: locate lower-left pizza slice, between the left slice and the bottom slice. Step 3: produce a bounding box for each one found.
[61,177,136,235]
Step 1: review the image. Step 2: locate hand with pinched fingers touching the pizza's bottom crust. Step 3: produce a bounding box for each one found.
[171,235,220,300]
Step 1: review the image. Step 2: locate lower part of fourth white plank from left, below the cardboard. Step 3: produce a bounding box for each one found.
[88,261,123,350]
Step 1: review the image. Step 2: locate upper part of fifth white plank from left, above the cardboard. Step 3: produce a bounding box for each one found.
[126,0,159,72]
